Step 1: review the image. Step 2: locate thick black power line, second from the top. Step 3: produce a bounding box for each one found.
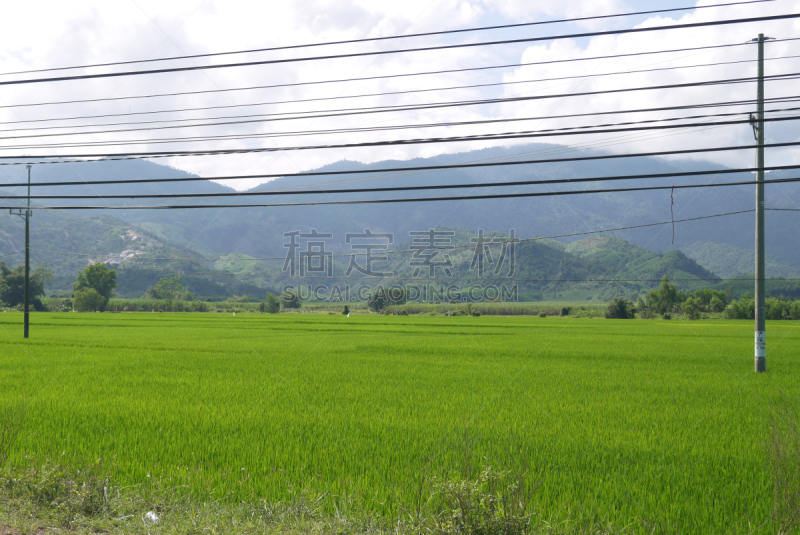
[0,14,800,86]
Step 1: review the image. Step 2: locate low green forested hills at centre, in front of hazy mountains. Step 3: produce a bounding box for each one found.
[183,227,720,300]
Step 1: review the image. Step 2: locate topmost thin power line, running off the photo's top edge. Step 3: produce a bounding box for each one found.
[0,0,775,76]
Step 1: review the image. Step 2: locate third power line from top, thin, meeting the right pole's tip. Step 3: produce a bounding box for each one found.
[6,37,800,109]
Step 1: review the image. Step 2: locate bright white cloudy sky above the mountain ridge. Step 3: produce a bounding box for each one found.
[0,0,800,189]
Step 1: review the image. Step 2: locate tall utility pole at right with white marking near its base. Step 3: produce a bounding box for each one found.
[750,33,773,372]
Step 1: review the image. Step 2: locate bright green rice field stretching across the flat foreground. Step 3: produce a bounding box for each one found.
[0,312,800,533]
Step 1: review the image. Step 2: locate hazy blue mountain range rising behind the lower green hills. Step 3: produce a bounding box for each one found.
[0,144,800,300]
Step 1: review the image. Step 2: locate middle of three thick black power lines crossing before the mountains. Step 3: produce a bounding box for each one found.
[10,165,800,199]
